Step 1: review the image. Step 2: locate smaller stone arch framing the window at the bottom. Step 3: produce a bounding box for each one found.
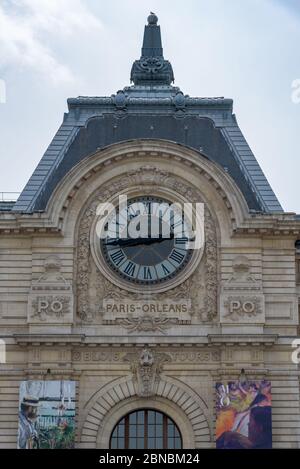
[80,376,212,449]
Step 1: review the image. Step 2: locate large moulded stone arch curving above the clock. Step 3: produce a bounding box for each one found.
[47,139,249,238]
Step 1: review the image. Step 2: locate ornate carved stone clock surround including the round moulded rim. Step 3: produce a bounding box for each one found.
[76,165,218,323]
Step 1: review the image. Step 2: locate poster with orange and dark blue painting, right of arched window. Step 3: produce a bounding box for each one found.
[216,380,272,449]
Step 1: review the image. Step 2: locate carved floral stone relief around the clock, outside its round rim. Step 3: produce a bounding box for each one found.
[76,165,218,323]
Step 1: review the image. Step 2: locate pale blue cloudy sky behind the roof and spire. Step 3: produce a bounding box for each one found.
[0,0,300,213]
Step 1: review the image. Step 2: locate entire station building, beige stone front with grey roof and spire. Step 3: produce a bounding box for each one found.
[0,14,300,448]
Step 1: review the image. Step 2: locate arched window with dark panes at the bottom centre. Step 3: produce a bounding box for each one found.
[110,409,182,449]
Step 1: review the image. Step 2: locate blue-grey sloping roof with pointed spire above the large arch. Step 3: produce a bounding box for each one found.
[13,15,283,212]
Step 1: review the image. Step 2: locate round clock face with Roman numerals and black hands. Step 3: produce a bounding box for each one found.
[100,196,192,285]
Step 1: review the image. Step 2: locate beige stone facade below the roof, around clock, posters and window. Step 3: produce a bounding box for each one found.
[0,139,300,448]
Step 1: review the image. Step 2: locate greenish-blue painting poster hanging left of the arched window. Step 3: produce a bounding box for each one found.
[18,381,75,449]
